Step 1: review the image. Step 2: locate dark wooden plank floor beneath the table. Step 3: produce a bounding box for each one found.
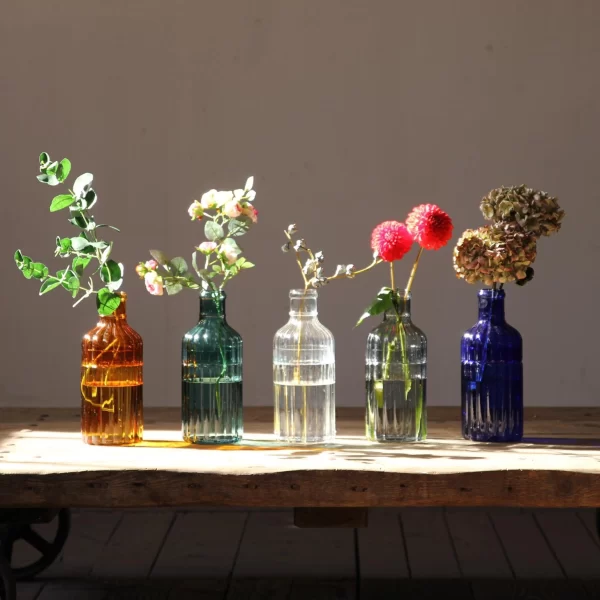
[10,508,600,600]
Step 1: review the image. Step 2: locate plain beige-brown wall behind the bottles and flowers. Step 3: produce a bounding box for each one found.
[0,0,600,407]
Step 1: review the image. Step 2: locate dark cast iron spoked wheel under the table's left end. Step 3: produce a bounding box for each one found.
[0,508,71,580]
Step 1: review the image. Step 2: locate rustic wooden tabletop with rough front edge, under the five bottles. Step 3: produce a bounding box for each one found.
[0,408,600,508]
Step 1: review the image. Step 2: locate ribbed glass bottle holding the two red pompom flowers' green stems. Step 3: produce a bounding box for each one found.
[366,293,427,442]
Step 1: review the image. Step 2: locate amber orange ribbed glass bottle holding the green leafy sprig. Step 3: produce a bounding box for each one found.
[81,292,144,446]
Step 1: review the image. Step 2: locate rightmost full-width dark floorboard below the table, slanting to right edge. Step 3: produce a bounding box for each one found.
[534,510,600,579]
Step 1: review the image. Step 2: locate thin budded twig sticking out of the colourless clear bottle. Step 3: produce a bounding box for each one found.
[281,224,382,289]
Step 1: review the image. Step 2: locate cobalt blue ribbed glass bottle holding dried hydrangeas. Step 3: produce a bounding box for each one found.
[461,289,523,442]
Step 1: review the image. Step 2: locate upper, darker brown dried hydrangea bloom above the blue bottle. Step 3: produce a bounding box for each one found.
[480,185,565,238]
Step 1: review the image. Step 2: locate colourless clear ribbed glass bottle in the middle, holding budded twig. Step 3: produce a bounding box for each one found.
[273,290,335,444]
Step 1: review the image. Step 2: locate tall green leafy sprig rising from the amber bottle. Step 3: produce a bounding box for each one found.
[14,152,123,315]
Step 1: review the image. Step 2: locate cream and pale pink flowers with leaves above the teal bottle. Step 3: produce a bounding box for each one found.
[136,177,258,296]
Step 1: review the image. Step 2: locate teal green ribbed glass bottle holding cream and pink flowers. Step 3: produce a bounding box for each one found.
[181,290,243,444]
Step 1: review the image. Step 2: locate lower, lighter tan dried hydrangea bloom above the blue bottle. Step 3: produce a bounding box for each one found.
[453,225,536,285]
